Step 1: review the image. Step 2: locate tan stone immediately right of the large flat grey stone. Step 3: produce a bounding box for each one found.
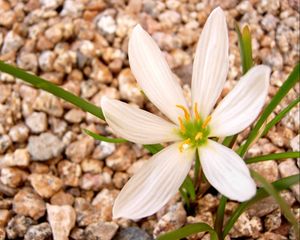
[66,136,95,163]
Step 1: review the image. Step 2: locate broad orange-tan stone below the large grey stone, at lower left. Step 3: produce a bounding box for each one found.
[29,173,63,198]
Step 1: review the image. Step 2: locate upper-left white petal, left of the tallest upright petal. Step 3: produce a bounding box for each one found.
[128,25,187,123]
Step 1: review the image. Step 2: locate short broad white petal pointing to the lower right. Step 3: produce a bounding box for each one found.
[198,140,256,202]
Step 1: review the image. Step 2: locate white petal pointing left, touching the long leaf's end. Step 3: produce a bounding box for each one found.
[101,97,180,144]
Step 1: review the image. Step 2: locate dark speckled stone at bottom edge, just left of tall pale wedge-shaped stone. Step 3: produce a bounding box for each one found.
[24,222,52,240]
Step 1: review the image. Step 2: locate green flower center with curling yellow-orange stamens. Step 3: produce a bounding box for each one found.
[176,103,211,152]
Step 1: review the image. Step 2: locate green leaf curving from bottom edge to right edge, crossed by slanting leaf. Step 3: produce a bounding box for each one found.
[223,174,300,238]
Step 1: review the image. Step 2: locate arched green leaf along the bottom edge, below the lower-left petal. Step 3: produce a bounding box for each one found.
[156,223,218,240]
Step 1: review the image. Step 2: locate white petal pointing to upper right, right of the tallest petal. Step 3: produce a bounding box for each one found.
[209,65,271,137]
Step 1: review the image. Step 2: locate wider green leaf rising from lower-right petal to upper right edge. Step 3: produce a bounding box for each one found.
[239,64,300,156]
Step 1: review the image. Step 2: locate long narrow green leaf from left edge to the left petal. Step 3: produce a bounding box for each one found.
[0,61,105,120]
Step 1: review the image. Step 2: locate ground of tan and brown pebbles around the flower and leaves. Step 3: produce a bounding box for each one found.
[0,0,300,240]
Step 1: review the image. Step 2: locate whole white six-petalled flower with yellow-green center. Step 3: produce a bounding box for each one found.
[101,8,270,219]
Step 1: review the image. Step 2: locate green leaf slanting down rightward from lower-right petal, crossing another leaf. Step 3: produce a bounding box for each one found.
[251,170,300,232]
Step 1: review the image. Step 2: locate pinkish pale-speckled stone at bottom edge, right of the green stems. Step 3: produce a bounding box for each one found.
[229,212,263,238]
